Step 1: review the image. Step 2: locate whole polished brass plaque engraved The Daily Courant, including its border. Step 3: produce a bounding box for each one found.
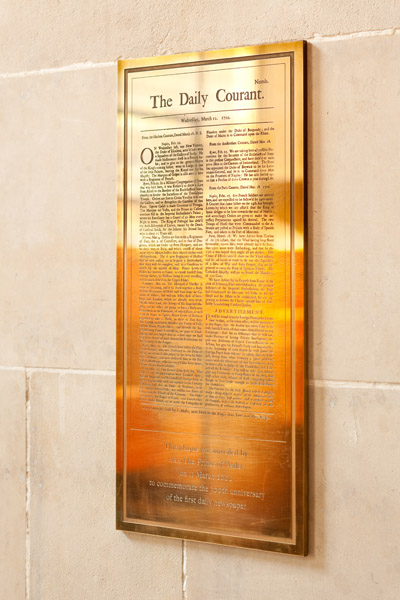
[117,42,307,555]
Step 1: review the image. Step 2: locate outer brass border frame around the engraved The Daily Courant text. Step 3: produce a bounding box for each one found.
[116,41,308,556]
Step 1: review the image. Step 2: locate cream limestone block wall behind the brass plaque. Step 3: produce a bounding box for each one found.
[0,0,400,600]
